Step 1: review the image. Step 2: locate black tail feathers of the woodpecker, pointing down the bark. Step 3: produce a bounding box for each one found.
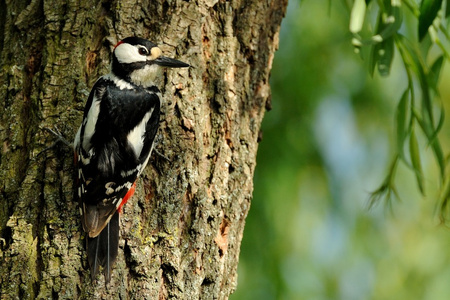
[87,212,119,283]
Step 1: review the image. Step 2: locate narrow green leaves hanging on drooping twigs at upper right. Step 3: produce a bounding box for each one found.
[350,0,449,216]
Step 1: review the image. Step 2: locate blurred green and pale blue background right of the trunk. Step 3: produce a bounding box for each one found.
[234,0,450,300]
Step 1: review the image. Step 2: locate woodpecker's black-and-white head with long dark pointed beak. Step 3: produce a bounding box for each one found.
[111,37,189,87]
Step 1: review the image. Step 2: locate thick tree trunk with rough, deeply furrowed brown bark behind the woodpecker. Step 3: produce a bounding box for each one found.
[0,0,287,299]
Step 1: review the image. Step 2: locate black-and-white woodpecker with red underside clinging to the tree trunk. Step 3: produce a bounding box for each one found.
[74,37,189,283]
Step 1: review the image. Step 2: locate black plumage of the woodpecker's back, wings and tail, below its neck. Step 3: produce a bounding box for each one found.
[78,78,160,281]
